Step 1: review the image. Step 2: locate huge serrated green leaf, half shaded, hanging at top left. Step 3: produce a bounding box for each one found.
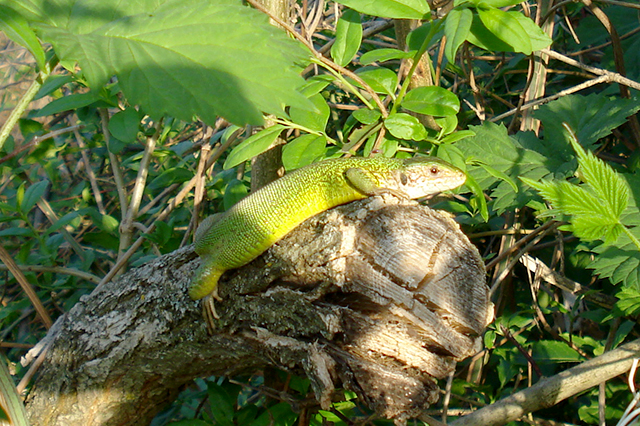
[17,0,309,124]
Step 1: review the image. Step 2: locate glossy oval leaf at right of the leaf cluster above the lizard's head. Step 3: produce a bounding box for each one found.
[401,86,460,117]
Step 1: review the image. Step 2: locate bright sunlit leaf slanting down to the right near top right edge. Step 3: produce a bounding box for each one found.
[477,8,533,55]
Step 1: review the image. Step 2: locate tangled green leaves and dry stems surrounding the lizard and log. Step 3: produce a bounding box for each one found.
[0,0,640,426]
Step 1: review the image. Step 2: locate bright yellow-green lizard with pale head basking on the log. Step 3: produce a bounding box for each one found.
[189,157,466,300]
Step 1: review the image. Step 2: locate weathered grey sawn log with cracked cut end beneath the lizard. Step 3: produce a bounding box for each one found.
[21,197,491,426]
